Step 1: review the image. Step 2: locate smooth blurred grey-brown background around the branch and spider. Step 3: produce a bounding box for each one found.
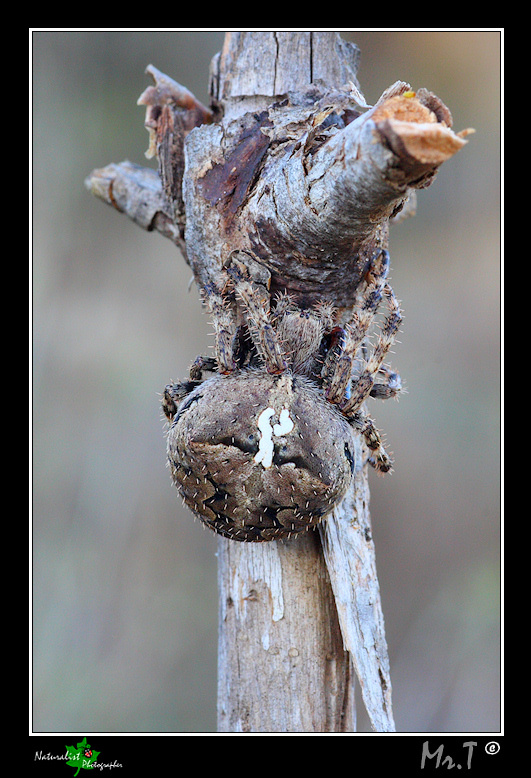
[31,30,501,733]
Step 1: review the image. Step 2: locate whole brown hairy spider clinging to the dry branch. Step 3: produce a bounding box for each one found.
[162,250,402,542]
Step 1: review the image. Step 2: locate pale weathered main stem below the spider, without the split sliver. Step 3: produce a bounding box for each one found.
[218,532,355,733]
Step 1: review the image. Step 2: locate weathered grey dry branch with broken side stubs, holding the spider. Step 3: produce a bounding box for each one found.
[87,31,467,732]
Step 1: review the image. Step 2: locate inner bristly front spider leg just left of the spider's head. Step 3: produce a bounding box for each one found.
[227,252,287,374]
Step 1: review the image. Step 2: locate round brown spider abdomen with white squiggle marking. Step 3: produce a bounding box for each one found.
[168,370,355,541]
